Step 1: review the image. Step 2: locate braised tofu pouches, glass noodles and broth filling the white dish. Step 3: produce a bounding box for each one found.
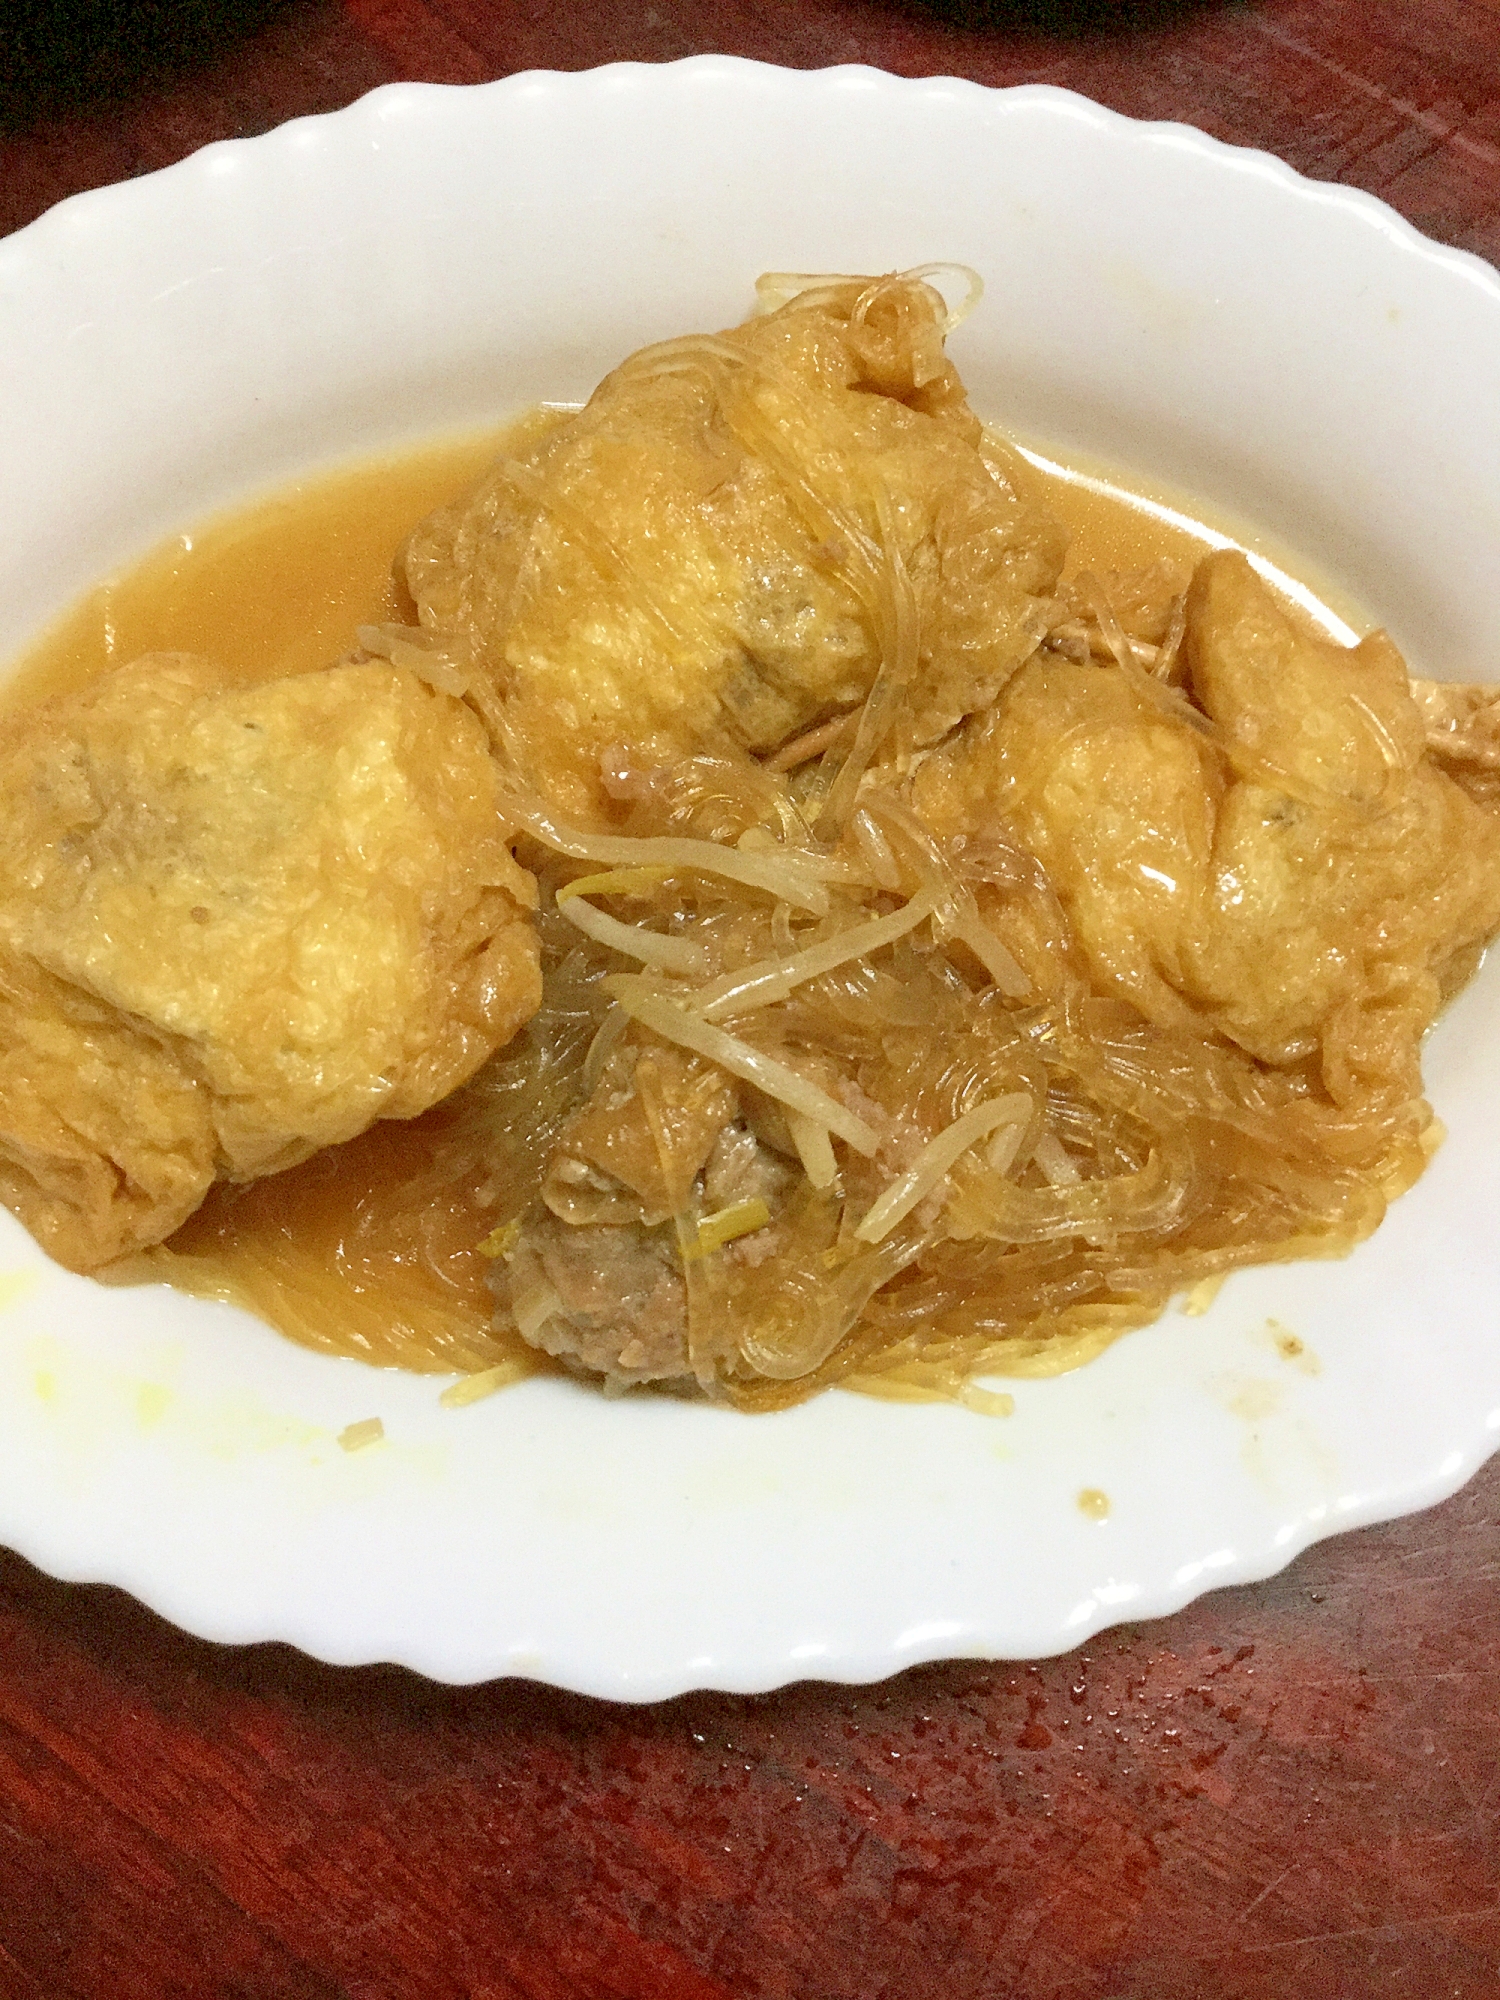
[0,272,1500,1410]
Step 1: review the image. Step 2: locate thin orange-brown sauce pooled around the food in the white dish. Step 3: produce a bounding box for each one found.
[0,412,1346,1372]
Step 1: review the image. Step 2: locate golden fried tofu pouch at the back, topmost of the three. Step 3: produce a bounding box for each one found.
[404,278,1066,816]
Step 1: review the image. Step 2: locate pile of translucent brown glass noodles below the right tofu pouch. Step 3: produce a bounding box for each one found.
[482,728,1430,1410]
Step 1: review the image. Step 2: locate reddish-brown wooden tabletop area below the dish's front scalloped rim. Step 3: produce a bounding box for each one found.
[0,1472,1500,2000]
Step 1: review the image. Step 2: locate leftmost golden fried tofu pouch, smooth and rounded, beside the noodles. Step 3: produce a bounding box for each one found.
[0,654,542,1270]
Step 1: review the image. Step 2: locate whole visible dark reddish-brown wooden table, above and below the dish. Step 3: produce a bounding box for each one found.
[0,0,1500,2000]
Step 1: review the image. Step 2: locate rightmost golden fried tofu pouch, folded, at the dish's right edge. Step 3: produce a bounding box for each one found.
[918,552,1500,1106]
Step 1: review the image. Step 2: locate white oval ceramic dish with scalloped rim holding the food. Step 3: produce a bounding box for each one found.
[0,58,1500,1698]
